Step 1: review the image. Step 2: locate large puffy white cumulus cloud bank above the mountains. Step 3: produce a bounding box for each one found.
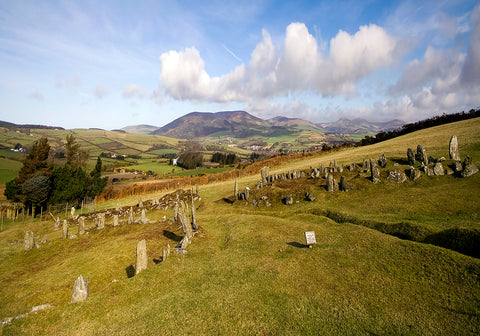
[160,23,400,102]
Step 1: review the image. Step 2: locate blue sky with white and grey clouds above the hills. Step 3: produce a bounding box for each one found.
[0,0,480,130]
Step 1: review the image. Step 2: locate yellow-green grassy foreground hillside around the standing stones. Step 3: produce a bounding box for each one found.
[0,121,480,335]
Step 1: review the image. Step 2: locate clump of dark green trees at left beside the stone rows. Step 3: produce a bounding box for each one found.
[4,134,107,214]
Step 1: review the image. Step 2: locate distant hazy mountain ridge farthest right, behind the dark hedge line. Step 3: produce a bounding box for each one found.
[317,118,405,134]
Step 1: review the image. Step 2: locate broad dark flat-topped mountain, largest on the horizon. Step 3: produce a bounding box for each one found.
[151,111,272,139]
